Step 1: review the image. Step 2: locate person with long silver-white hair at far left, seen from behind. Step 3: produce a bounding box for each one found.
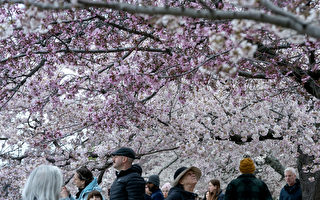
[22,165,63,200]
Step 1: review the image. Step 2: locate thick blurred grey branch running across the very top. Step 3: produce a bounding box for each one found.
[0,0,320,38]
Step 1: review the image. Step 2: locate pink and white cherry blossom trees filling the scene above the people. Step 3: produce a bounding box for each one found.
[0,0,320,199]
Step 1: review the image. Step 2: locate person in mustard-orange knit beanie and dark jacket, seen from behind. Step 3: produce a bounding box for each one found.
[224,158,272,200]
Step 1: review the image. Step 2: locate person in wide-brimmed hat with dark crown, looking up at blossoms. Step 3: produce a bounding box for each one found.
[166,166,201,200]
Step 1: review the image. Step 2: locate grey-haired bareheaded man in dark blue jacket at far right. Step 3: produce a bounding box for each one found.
[279,167,302,200]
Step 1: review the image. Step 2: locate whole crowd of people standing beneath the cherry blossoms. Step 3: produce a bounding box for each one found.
[22,147,302,200]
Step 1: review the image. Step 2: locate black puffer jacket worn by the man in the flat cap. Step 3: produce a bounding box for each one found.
[110,164,145,200]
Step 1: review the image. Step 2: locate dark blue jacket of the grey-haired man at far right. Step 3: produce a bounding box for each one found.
[279,179,302,200]
